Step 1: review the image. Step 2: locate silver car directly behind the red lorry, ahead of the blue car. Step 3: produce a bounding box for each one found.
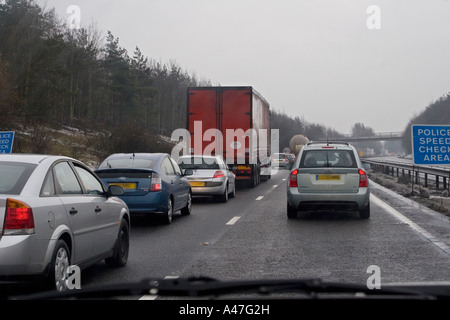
[178,155,236,202]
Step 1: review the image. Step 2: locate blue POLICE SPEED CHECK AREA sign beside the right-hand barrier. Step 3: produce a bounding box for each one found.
[411,125,450,165]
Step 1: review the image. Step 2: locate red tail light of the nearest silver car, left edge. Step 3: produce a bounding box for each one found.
[3,199,34,235]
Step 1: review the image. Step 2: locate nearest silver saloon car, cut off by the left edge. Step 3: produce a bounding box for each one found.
[0,154,130,291]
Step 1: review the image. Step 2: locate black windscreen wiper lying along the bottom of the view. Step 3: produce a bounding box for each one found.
[11,277,450,300]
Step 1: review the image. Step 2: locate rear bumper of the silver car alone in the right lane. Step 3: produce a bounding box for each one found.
[287,188,370,211]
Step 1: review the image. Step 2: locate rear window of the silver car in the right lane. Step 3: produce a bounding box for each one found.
[300,149,358,168]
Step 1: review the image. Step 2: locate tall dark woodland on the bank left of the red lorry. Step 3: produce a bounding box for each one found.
[0,0,210,136]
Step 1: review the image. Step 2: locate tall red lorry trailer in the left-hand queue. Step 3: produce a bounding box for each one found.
[187,87,271,187]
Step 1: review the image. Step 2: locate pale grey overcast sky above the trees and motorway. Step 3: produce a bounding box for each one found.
[38,0,450,133]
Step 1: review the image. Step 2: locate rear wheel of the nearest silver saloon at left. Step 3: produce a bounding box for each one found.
[48,240,70,291]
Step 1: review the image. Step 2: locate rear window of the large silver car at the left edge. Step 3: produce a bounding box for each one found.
[0,162,37,195]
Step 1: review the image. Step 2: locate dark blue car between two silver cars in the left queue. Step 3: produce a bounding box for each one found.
[95,153,192,223]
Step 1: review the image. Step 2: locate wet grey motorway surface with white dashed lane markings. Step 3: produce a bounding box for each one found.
[77,170,450,298]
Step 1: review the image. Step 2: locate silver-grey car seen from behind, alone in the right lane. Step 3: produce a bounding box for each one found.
[287,142,370,219]
